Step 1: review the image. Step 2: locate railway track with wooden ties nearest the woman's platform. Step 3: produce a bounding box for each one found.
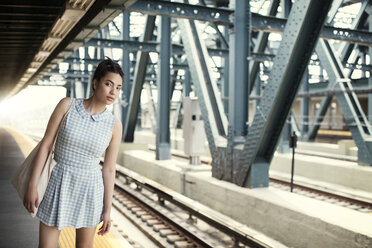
[113,165,277,248]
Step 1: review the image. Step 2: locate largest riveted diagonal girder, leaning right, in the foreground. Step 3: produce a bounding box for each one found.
[234,0,331,187]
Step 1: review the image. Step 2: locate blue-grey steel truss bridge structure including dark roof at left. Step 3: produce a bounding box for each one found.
[0,0,372,188]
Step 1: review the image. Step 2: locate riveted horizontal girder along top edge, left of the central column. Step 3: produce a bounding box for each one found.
[109,0,233,25]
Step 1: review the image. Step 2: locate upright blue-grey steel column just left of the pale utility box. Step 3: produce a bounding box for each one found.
[156,16,171,160]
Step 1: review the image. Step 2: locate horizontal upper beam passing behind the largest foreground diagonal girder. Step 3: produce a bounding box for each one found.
[252,13,372,46]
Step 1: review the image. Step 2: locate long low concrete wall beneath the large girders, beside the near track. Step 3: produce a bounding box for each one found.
[122,150,372,247]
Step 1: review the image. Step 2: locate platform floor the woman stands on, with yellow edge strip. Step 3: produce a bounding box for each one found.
[0,127,133,248]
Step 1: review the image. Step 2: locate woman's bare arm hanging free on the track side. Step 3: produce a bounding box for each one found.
[98,118,122,235]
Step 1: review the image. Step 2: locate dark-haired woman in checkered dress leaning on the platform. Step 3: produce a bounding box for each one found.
[24,58,124,248]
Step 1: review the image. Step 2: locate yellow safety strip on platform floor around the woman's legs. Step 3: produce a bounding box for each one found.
[58,226,121,248]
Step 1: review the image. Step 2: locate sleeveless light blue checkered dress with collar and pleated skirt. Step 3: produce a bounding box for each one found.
[36,99,115,230]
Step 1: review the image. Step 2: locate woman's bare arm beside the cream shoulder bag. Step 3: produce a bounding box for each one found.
[23,97,70,213]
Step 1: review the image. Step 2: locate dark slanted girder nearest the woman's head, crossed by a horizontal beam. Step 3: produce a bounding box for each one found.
[124,16,155,142]
